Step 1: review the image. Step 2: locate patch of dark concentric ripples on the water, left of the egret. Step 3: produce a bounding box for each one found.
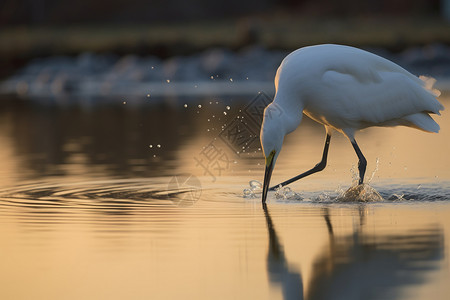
[0,179,193,214]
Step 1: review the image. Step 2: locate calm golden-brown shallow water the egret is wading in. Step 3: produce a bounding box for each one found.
[0,97,450,299]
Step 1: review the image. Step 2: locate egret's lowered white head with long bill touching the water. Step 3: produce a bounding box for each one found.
[261,103,286,202]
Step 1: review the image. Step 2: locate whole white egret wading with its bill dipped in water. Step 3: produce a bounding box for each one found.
[261,45,444,202]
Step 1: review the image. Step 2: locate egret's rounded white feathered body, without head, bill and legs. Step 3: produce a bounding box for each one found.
[274,45,444,134]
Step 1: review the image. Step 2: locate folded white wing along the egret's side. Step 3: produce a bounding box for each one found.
[322,65,444,124]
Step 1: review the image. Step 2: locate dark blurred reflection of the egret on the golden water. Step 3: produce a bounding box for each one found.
[263,203,443,300]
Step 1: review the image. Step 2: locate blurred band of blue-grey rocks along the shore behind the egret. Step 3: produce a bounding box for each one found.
[0,44,450,104]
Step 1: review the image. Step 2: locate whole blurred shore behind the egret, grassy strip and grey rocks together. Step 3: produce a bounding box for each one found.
[0,13,450,99]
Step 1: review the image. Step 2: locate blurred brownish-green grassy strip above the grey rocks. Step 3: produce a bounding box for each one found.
[0,13,450,74]
